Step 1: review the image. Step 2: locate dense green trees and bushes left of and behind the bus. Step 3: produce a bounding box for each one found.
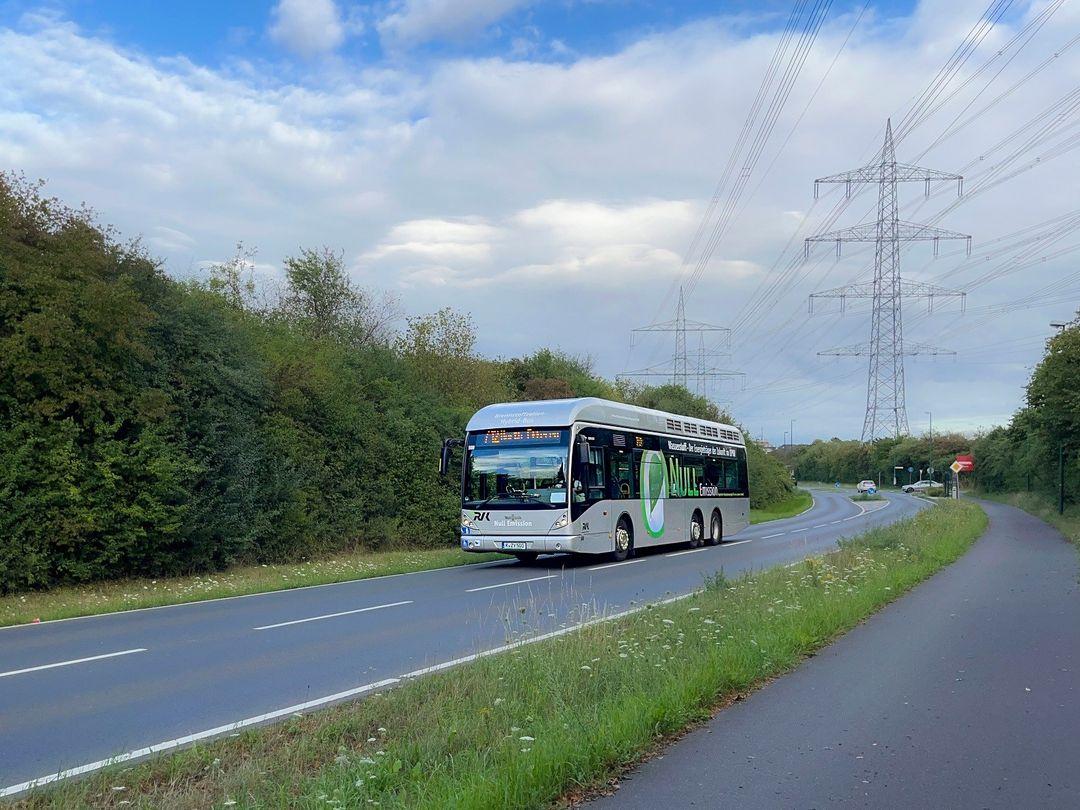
[0,175,789,592]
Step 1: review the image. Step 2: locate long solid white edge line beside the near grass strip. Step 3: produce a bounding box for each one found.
[0,591,695,798]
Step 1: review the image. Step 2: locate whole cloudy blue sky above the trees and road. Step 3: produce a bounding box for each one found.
[0,0,1080,444]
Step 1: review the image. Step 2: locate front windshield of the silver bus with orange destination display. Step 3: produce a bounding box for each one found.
[463,429,570,509]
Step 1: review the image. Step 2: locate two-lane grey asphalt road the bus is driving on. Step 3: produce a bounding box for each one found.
[0,491,926,795]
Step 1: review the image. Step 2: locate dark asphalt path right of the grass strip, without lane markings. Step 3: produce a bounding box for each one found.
[595,503,1080,810]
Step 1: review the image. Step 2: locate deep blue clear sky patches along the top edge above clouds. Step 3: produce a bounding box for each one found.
[0,0,913,67]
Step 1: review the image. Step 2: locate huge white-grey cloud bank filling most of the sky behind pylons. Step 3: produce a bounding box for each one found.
[0,0,1080,441]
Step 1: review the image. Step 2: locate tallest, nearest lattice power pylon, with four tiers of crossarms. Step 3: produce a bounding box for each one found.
[805,121,971,442]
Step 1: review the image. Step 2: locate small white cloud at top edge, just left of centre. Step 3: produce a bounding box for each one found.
[377,0,532,46]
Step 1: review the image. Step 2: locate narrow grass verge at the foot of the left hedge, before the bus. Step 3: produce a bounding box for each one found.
[0,546,507,626]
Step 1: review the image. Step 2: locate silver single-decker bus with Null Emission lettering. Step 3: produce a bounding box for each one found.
[440,397,750,562]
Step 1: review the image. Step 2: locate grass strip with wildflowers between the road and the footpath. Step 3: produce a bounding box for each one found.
[21,502,986,808]
